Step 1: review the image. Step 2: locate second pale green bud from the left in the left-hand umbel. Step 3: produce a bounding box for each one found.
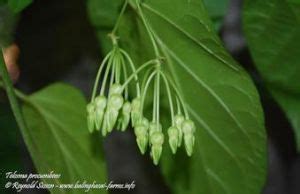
[95,96,107,130]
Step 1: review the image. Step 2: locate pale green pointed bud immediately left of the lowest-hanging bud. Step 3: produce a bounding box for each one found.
[134,124,148,154]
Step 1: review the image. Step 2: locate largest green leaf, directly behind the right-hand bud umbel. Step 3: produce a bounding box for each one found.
[118,0,266,194]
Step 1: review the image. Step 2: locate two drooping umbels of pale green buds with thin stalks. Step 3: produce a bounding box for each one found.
[87,42,195,164]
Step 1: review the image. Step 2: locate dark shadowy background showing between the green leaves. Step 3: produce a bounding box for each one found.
[0,0,300,194]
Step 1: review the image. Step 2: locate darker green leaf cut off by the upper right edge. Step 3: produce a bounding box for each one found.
[243,0,300,150]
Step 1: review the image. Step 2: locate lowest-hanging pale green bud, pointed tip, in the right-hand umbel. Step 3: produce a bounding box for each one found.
[150,131,164,165]
